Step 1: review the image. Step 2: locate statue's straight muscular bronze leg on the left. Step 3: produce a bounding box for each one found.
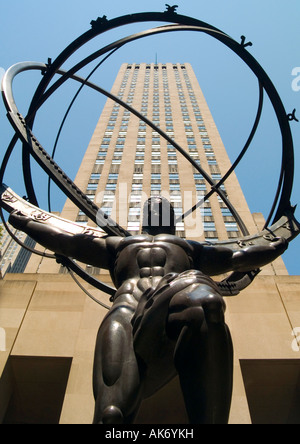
[93,306,141,424]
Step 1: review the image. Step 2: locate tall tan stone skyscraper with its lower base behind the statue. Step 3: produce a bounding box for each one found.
[0,63,300,424]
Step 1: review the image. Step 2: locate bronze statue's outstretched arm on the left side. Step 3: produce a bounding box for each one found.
[9,211,110,269]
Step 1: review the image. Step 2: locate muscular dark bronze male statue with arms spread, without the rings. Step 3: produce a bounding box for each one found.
[10,198,288,424]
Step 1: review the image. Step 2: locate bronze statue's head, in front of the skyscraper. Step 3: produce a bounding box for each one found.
[142,196,176,236]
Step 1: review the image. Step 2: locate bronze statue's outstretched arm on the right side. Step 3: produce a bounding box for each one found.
[191,238,288,276]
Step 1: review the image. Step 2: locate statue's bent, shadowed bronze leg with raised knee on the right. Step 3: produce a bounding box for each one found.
[168,283,233,424]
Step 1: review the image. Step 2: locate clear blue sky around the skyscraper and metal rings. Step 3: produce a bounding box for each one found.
[0,0,300,274]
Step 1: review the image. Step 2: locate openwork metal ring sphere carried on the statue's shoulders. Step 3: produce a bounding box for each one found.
[0,5,300,308]
